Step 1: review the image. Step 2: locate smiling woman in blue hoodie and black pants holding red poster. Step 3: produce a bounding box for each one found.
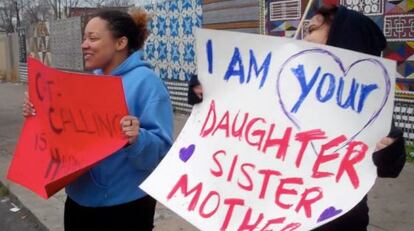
[23,8,173,231]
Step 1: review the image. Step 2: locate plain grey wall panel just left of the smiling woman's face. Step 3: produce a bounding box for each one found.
[50,17,83,71]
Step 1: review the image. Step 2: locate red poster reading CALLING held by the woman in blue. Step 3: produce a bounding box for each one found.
[7,59,128,198]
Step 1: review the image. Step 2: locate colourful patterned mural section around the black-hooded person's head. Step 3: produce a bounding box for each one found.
[263,0,414,91]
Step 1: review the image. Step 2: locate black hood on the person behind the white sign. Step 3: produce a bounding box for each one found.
[326,6,387,56]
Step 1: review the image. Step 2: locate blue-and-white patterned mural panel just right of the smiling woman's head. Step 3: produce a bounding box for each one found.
[144,0,202,81]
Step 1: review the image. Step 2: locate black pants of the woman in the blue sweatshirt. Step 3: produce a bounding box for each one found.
[64,196,156,231]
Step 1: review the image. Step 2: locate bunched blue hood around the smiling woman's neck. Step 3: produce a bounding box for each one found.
[94,50,151,76]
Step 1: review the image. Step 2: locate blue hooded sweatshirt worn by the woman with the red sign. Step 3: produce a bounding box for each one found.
[66,51,173,207]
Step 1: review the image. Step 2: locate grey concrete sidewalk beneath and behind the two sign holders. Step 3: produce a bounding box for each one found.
[0,83,414,231]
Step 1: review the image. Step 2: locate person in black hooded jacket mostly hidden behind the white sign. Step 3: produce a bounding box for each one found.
[188,5,406,231]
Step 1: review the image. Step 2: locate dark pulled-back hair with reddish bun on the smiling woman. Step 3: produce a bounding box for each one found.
[94,10,148,54]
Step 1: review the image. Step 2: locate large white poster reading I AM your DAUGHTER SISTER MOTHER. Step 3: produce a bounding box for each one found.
[141,30,395,230]
